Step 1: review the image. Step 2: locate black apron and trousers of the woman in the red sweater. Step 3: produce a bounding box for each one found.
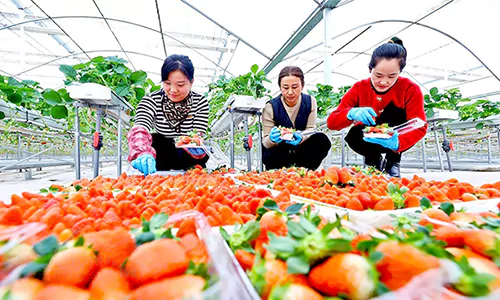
[345,103,407,166]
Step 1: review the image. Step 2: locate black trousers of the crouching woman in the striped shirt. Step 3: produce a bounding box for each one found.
[152,133,208,171]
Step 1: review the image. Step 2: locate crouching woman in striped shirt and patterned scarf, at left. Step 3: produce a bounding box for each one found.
[127,54,208,175]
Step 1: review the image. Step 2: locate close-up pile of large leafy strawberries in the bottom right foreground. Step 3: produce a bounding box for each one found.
[221,198,500,300]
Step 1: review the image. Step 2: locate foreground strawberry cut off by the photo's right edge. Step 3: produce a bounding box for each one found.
[464,229,500,260]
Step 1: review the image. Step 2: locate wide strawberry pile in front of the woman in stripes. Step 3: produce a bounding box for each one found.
[0,170,291,241]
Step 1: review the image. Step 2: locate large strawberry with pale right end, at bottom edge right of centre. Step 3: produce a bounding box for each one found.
[308,253,378,299]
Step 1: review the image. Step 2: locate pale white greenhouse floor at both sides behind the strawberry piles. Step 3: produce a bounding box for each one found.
[0,164,500,202]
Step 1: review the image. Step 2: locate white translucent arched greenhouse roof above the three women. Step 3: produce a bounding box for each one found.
[0,0,500,100]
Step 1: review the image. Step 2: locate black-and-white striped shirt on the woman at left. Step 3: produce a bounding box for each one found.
[135,89,208,138]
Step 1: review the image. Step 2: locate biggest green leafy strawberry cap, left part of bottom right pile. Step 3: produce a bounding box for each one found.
[266,216,352,274]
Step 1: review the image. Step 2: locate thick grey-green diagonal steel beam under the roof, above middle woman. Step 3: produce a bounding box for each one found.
[264,0,340,74]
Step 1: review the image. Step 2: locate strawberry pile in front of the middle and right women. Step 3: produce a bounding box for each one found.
[236,167,500,211]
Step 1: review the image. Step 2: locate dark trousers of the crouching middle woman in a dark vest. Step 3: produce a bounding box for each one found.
[262,132,331,170]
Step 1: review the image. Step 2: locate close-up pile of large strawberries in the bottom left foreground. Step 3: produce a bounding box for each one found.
[0,214,218,300]
